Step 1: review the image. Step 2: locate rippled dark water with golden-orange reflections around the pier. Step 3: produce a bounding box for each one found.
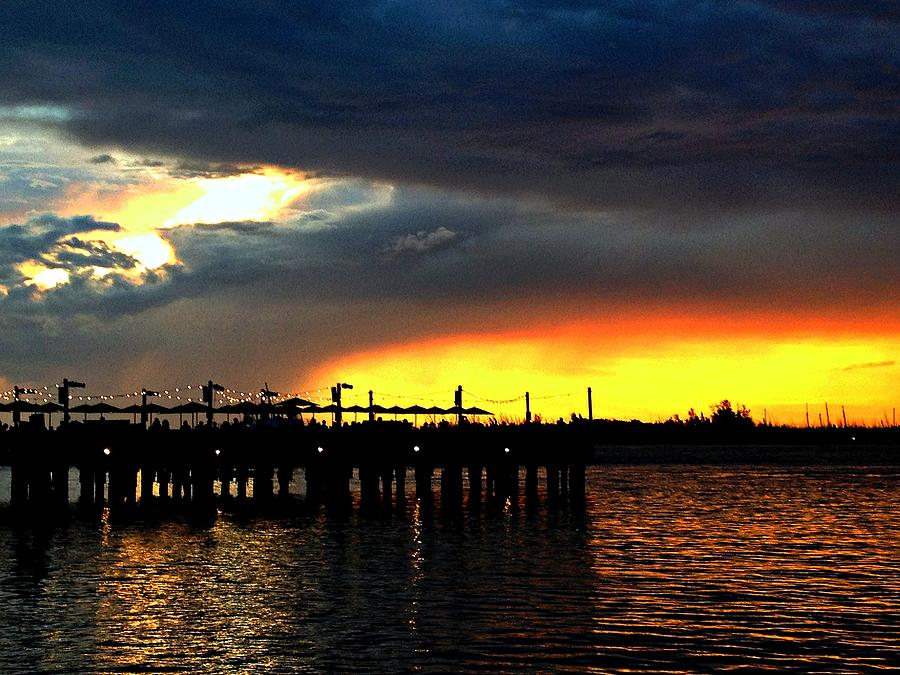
[0,467,900,673]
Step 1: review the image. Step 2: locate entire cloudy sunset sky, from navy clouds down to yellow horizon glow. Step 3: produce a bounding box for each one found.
[0,0,900,423]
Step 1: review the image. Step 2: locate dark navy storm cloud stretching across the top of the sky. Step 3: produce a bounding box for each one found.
[0,0,900,210]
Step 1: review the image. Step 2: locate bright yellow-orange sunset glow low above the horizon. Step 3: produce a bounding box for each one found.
[313,312,900,424]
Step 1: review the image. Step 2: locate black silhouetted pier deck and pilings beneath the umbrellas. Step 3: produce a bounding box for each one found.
[0,423,592,513]
